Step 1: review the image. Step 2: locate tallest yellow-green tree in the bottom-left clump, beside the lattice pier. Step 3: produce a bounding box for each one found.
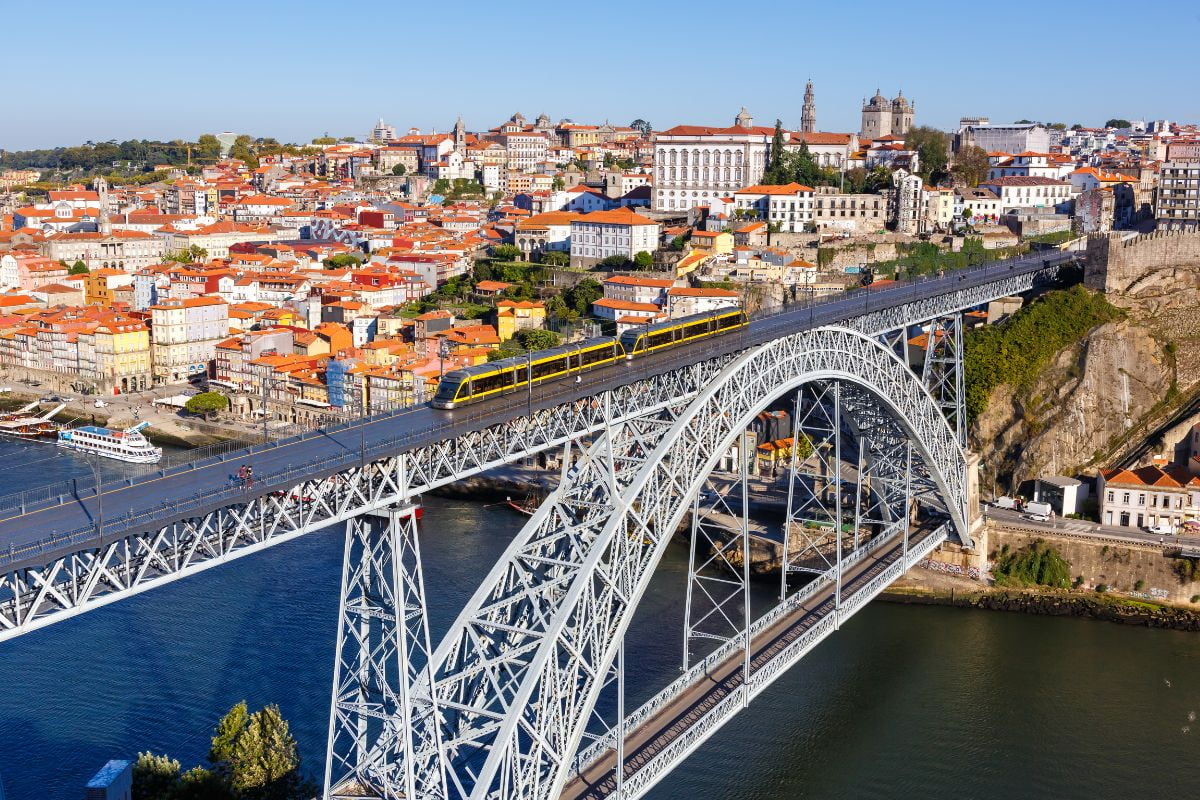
[229,705,305,800]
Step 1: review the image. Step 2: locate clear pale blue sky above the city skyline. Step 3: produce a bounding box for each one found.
[0,0,1200,149]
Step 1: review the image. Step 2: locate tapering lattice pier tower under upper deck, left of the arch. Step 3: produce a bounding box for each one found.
[325,504,445,800]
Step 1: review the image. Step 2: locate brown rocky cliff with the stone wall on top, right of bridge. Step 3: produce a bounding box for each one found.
[971,227,1200,484]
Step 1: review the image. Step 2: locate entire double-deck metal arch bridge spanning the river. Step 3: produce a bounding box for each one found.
[0,252,1072,798]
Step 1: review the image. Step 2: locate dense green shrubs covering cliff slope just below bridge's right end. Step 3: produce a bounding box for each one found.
[964,285,1124,421]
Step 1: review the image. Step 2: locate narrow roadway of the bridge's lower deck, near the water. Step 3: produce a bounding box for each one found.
[562,528,930,800]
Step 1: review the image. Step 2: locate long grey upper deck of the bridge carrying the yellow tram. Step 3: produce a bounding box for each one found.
[0,252,1070,567]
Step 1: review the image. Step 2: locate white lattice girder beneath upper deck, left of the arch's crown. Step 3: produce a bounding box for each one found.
[0,356,728,640]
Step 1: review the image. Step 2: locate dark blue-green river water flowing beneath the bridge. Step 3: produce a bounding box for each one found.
[0,443,1200,800]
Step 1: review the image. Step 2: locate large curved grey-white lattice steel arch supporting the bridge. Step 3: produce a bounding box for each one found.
[398,327,967,800]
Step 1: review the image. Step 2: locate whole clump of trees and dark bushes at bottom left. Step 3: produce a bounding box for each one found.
[133,700,317,800]
